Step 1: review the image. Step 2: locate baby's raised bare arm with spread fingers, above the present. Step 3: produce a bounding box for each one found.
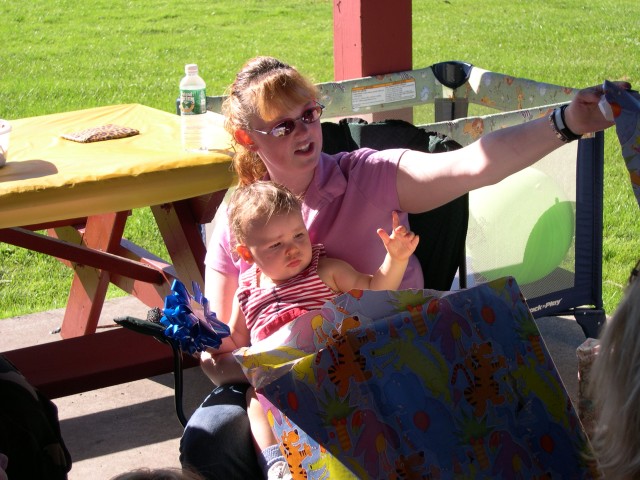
[318,212,420,292]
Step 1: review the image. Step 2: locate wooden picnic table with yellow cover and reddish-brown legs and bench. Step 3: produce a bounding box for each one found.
[0,104,233,398]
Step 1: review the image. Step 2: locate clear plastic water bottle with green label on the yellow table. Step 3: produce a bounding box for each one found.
[180,63,207,152]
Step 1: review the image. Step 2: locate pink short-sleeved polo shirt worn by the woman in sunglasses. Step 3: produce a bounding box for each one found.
[205,148,424,288]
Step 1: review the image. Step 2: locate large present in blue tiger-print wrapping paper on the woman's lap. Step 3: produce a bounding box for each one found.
[236,277,598,479]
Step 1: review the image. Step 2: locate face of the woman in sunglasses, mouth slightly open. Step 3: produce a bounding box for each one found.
[248,100,322,189]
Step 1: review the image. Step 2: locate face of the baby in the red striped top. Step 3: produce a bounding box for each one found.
[238,212,311,283]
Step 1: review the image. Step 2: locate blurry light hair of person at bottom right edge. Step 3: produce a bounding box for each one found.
[591,260,640,479]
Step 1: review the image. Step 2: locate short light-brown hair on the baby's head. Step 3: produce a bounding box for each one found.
[227,181,302,243]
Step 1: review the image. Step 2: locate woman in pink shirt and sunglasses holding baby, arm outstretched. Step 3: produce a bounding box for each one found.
[181,57,630,478]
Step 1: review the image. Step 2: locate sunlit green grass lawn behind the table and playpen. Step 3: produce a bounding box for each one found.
[0,0,640,318]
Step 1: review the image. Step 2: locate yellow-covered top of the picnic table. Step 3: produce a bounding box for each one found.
[0,104,234,228]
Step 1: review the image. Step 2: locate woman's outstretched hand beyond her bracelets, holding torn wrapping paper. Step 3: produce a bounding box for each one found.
[564,82,631,135]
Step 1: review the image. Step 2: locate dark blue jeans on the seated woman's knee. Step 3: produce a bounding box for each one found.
[180,384,263,480]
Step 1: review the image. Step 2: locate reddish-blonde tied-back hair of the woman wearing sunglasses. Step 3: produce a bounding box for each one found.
[222,57,318,185]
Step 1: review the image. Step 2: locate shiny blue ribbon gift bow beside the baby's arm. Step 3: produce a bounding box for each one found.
[160,279,230,355]
